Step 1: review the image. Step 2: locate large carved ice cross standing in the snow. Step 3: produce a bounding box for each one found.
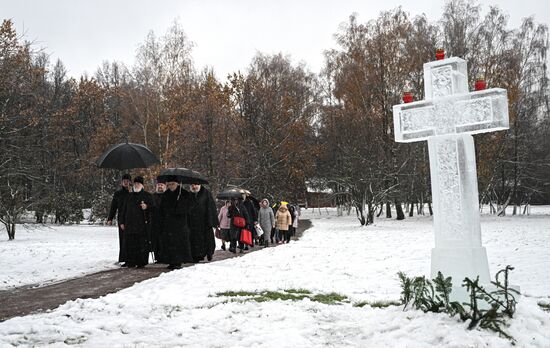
[393,57,508,285]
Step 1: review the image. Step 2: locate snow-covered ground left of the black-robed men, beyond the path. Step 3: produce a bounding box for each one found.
[0,225,119,290]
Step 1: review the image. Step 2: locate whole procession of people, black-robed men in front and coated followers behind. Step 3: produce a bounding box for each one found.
[107,174,299,269]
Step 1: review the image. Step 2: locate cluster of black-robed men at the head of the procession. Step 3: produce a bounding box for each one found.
[107,174,218,269]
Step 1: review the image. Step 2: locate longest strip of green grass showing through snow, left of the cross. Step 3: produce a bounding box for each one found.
[216,289,348,304]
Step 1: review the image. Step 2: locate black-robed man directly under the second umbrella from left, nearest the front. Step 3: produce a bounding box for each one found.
[159,177,193,269]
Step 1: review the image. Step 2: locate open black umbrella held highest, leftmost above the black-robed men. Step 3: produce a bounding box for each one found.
[97,143,160,170]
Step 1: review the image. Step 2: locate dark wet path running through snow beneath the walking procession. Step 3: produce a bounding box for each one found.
[0,220,311,321]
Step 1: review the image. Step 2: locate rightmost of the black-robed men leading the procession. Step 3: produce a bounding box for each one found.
[189,184,220,262]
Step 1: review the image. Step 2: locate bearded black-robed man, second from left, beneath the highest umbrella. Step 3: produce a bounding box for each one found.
[119,176,155,268]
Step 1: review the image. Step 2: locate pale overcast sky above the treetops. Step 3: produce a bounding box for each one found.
[0,0,550,78]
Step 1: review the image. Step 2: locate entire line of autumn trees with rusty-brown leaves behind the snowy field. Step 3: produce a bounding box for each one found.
[0,1,550,238]
